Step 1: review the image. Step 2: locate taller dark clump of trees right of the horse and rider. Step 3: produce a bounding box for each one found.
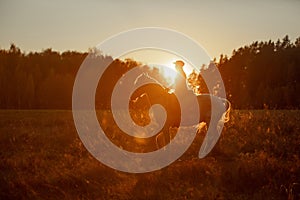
[189,36,300,109]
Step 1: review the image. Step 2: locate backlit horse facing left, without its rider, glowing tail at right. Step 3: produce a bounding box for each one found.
[130,74,231,149]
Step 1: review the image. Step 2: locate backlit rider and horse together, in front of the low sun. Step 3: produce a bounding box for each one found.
[132,60,231,151]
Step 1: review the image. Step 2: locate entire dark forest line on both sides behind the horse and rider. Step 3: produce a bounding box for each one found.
[0,36,300,109]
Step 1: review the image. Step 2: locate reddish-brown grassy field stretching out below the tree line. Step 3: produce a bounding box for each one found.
[0,110,300,199]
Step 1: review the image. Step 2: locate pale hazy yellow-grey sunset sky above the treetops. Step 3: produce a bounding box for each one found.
[0,0,300,58]
